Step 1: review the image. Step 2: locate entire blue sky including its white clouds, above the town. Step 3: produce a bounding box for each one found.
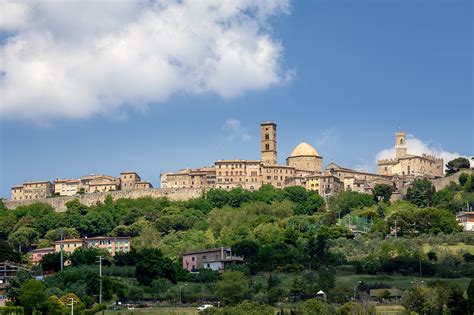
[0,0,474,198]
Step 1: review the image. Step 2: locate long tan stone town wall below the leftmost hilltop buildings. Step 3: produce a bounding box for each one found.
[3,188,203,212]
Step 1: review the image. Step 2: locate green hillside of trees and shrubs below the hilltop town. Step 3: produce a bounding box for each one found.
[0,179,474,314]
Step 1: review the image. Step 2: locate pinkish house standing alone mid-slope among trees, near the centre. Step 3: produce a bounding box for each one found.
[183,247,244,272]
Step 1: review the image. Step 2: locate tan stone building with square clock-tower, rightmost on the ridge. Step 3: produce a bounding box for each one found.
[377,131,444,178]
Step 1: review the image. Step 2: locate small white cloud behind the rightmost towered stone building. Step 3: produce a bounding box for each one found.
[376,134,461,168]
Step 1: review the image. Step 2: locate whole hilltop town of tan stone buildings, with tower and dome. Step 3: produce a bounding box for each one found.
[11,122,444,205]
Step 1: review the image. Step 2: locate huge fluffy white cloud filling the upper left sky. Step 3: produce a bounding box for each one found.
[0,0,290,121]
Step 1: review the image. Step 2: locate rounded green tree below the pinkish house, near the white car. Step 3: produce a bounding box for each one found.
[216,271,249,304]
